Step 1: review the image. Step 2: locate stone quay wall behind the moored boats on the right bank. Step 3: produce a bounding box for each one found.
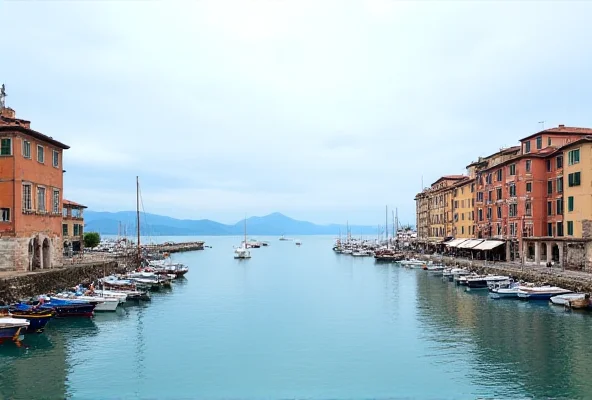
[413,254,592,293]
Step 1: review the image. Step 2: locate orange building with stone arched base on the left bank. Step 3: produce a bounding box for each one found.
[0,90,69,271]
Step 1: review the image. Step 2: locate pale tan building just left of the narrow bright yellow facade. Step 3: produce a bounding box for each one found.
[428,175,466,242]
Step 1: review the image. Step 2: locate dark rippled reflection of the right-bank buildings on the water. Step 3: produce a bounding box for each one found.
[417,273,592,399]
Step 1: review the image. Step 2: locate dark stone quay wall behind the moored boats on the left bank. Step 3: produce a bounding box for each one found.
[0,261,124,305]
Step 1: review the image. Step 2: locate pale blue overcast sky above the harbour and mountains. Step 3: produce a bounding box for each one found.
[0,0,592,225]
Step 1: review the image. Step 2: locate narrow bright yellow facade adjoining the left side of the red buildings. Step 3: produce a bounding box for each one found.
[452,177,475,238]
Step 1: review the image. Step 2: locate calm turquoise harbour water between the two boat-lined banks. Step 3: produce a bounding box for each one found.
[0,236,592,399]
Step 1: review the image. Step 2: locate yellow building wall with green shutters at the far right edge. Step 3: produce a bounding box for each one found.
[563,138,592,238]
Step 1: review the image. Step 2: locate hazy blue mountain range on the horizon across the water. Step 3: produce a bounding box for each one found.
[84,210,376,236]
